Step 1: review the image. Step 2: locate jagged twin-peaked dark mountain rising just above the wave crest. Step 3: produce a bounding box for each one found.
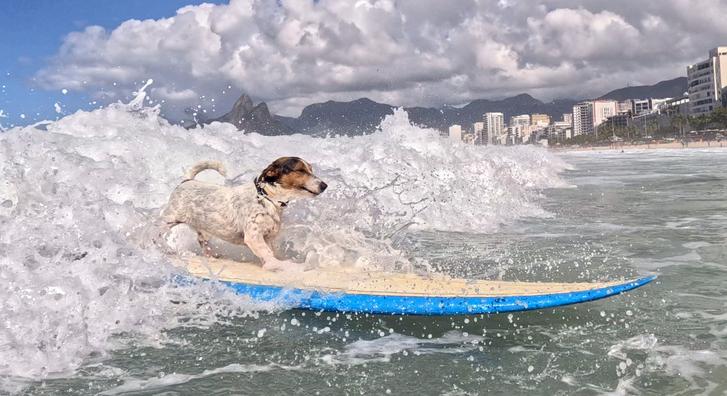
[203,94,295,136]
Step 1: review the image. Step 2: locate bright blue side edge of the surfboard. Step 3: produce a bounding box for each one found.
[209,275,656,316]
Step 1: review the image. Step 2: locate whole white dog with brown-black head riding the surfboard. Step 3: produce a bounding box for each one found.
[161,157,328,271]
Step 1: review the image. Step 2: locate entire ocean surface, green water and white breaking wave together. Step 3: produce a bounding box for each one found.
[0,92,727,395]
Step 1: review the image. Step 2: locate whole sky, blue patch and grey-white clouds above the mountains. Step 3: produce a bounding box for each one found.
[0,0,727,126]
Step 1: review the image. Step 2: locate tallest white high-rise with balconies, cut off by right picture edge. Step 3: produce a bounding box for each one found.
[687,47,727,115]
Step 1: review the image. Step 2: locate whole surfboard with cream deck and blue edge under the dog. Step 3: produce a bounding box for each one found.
[174,256,656,315]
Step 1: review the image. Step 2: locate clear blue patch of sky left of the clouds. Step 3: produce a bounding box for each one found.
[0,0,224,127]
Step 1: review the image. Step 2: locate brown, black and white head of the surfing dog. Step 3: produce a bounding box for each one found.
[258,157,328,198]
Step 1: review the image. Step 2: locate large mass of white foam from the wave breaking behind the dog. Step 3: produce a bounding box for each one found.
[0,85,566,386]
